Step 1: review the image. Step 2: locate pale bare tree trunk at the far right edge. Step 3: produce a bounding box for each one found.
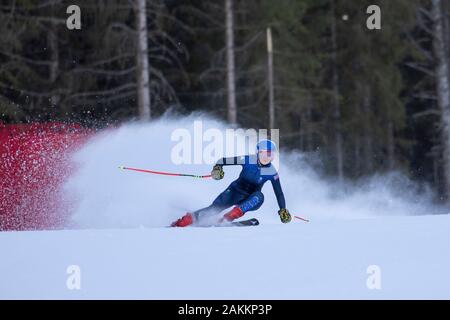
[431,0,450,201]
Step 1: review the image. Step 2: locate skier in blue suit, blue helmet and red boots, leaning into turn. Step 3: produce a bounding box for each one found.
[171,140,291,227]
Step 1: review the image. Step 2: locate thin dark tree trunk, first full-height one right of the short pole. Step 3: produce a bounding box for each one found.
[331,0,344,180]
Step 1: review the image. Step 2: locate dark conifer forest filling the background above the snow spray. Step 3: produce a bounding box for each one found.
[0,0,450,201]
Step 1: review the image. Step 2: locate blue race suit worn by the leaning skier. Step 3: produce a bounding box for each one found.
[193,155,286,220]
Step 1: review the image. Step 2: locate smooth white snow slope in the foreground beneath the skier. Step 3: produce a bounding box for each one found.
[0,215,450,299]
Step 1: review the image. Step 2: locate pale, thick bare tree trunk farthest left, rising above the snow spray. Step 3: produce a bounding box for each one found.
[135,0,151,121]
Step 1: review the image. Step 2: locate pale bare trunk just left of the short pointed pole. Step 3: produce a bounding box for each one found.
[225,0,237,126]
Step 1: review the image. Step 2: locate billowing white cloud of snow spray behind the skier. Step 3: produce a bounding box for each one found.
[65,114,437,228]
